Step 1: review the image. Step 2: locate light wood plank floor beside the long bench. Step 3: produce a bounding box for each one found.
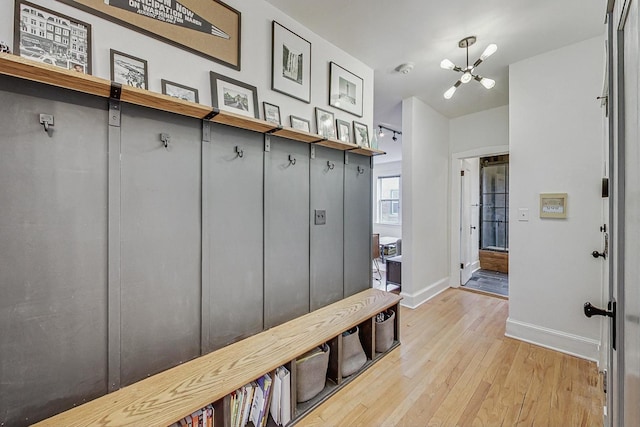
[297,289,604,427]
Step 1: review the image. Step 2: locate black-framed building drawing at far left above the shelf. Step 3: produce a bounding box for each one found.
[13,0,91,74]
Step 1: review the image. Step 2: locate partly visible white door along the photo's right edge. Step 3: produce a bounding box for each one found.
[604,0,640,427]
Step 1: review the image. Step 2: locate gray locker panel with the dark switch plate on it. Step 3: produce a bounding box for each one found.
[309,146,344,310]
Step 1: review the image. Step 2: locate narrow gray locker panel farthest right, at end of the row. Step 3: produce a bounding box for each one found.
[344,153,372,298]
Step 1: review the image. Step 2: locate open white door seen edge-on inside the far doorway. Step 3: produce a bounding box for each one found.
[460,160,474,285]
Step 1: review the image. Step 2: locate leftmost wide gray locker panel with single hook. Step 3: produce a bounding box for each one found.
[0,77,107,426]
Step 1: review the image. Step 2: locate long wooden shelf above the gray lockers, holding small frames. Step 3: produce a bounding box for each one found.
[0,53,385,156]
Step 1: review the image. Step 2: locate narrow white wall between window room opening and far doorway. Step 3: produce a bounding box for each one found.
[402,98,449,307]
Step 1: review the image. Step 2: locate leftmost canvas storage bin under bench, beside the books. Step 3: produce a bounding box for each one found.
[296,344,329,402]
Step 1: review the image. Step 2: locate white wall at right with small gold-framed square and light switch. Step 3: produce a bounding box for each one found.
[507,37,604,360]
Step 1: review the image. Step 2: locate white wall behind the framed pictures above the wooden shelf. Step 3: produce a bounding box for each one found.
[0,0,373,131]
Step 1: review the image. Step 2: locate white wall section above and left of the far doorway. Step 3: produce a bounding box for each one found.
[449,105,509,287]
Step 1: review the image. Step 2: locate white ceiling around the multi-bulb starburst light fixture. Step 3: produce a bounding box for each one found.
[260,0,606,129]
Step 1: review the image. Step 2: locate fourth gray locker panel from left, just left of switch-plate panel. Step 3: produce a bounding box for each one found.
[264,136,309,328]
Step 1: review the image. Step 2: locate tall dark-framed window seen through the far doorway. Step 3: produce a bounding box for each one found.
[480,154,509,251]
